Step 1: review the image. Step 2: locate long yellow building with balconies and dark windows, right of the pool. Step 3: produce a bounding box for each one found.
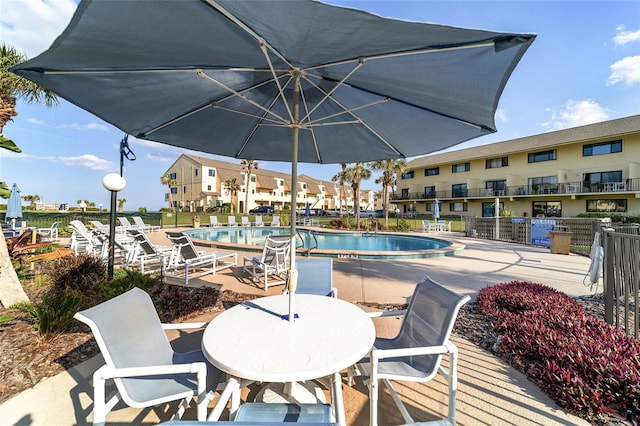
[391,115,640,217]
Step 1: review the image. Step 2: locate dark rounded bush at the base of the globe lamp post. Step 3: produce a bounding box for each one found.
[48,254,107,308]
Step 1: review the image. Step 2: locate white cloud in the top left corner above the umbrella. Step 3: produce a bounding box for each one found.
[0,0,77,58]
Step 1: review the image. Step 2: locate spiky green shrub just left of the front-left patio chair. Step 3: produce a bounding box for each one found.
[17,290,82,340]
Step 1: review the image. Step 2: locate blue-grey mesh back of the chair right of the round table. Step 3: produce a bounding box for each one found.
[393,277,469,374]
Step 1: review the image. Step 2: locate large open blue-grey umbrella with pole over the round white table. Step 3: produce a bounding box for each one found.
[11,0,535,320]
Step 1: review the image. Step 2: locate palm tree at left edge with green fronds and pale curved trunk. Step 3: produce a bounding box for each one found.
[0,43,58,307]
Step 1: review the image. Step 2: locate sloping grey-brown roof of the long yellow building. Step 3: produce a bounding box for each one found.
[407,115,640,169]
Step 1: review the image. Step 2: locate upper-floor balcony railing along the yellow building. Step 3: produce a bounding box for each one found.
[390,178,640,201]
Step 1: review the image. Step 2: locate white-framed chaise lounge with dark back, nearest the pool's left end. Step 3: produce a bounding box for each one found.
[164,232,238,285]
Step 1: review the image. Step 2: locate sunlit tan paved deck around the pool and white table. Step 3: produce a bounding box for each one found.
[0,232,590,426]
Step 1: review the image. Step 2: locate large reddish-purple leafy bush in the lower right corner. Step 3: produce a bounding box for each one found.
[477,281,640,424]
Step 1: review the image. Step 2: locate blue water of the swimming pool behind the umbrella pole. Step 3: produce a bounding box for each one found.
[185,227,451,257]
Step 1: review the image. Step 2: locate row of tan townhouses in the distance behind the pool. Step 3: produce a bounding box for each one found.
[165,154,375,213]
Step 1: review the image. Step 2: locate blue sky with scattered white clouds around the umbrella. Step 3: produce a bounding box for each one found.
[0,0,640,211]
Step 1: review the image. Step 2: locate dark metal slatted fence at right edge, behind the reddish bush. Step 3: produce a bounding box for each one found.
[602,231,640,339]
